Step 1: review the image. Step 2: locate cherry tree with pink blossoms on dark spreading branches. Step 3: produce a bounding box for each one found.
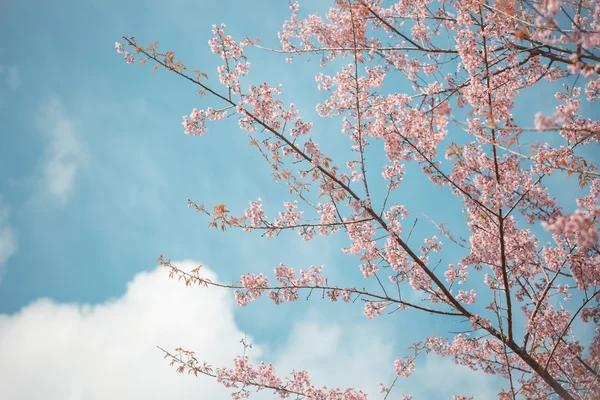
[116,0,600,400]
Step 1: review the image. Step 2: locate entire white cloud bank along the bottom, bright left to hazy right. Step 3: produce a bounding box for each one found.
[0,261,506,400]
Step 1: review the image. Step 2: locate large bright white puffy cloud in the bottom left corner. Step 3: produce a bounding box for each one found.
[0,262,246,400]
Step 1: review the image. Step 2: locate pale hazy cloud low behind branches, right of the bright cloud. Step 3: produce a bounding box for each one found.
[266,313,505,400]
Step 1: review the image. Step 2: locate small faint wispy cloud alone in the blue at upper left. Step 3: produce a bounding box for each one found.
[38,99,87,204]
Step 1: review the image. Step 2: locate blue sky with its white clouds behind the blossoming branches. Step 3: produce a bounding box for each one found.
[0,0,592,399]
